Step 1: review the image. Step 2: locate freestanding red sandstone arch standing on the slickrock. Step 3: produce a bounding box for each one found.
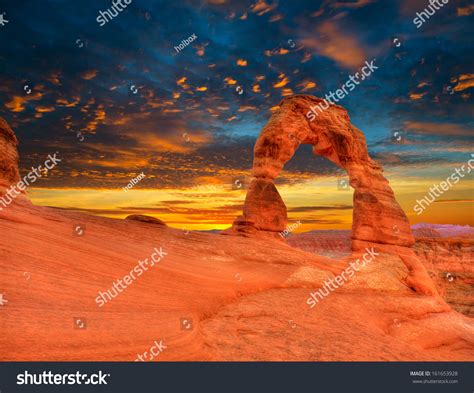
[224,95,436,294]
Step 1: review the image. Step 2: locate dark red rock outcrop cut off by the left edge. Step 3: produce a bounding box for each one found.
[0,117,20,188]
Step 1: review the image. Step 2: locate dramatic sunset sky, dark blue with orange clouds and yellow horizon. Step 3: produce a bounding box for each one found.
[0,0,474,231]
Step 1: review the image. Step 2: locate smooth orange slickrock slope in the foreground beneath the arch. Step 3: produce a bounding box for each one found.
[0,115,474,361]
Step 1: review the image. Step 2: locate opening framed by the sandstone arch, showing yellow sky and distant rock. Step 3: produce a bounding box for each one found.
[275,144,353,260]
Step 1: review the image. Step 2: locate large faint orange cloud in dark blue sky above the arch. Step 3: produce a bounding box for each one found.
[301,21,367,69]
